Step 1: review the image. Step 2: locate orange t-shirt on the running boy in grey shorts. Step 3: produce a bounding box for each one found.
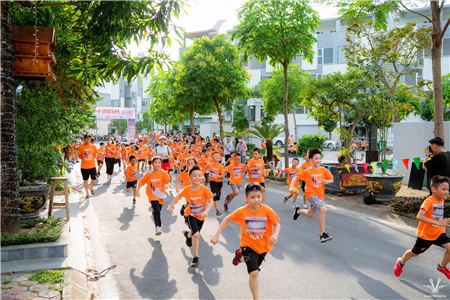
[297,167,333,200]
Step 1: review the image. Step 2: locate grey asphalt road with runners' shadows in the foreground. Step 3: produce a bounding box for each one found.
[89,167,450,299]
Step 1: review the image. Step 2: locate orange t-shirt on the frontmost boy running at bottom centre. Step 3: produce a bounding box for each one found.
[229,204,280,254]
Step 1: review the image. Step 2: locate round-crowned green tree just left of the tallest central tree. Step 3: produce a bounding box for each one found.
[177,34,250,134]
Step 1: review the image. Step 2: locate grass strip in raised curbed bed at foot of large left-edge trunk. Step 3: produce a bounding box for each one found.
[0,217,65,246]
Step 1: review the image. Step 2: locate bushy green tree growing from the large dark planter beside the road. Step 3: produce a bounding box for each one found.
[302,69,379,164]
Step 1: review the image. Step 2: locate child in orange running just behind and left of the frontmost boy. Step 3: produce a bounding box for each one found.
[167,166,213,267]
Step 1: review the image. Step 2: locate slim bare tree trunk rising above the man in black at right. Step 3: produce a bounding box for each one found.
[430,0,445,139]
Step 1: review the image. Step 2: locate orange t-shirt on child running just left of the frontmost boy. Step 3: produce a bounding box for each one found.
[180,185,213,221]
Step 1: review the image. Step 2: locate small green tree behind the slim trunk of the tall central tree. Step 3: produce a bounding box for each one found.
[262,64,309,139]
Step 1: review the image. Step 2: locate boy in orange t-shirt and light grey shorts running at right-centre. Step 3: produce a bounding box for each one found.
[290,148,334,243]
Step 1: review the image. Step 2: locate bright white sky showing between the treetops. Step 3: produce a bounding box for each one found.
[128,0,337,60]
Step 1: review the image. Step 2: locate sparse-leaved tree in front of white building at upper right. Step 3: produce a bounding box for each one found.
[344,19,431,122]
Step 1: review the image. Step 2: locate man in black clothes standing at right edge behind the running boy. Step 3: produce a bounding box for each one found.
[423,137,450,195]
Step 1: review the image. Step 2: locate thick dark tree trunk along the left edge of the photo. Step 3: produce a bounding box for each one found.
[0,0,20,234]
